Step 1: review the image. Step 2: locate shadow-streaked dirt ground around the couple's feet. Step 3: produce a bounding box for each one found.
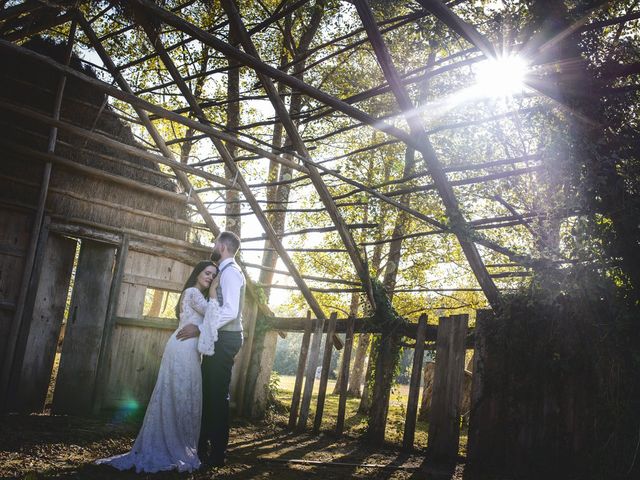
[0,415,482,480]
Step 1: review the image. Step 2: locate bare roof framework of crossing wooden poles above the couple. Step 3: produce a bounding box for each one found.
[0,0,638,448]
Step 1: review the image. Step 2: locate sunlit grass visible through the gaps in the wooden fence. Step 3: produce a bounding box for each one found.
[276,375,438,449]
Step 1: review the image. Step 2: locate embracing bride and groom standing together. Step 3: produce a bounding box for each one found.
[96,232,245,473]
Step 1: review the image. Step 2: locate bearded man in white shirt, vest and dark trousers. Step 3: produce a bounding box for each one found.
[178,232,245,466]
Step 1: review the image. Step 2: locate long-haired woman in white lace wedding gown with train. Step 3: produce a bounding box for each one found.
[96,261,220,473]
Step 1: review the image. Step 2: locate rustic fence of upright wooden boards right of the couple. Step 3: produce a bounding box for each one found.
[274,312,471,462]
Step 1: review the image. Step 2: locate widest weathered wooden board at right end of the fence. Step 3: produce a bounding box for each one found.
[428,315,469,462]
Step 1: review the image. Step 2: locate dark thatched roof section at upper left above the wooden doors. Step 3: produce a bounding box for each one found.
[0,38,189,240]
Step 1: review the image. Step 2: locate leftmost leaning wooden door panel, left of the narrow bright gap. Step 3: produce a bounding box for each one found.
[16,233,77,412]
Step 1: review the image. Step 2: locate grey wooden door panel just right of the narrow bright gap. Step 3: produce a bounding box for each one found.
[52,240,116,415]
